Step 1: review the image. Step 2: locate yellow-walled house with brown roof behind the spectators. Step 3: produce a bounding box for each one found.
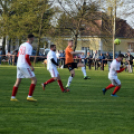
[55,12,134,53]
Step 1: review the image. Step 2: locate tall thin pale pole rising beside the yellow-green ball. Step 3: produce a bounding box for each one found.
[113,0,116,59]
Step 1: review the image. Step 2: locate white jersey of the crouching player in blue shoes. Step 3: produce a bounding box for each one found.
[108,59,121,79]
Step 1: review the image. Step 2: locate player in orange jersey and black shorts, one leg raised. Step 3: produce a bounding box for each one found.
[65,40,90,89]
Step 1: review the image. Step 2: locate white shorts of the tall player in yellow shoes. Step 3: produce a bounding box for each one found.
[17,67,35,78]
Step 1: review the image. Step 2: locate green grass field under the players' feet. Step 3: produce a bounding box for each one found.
[0,66,134,134]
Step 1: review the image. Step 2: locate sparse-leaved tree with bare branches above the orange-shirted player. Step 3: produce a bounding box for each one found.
[50,0,100,50]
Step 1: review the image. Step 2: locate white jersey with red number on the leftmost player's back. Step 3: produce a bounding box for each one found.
[17,42,33,68]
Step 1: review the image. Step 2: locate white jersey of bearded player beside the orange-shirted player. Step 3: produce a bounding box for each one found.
[47,50,57,70]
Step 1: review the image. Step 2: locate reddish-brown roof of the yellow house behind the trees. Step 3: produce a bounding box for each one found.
[56,12,134,38]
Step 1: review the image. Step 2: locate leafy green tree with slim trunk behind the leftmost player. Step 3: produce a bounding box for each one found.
[7,0,54,59]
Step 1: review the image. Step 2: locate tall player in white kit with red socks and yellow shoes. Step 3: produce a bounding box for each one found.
[11,34,37,102]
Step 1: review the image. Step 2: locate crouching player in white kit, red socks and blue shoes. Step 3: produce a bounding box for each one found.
[102,54,125,97]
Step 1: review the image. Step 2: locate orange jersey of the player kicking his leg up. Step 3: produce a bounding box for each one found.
[65,46,74,64]
